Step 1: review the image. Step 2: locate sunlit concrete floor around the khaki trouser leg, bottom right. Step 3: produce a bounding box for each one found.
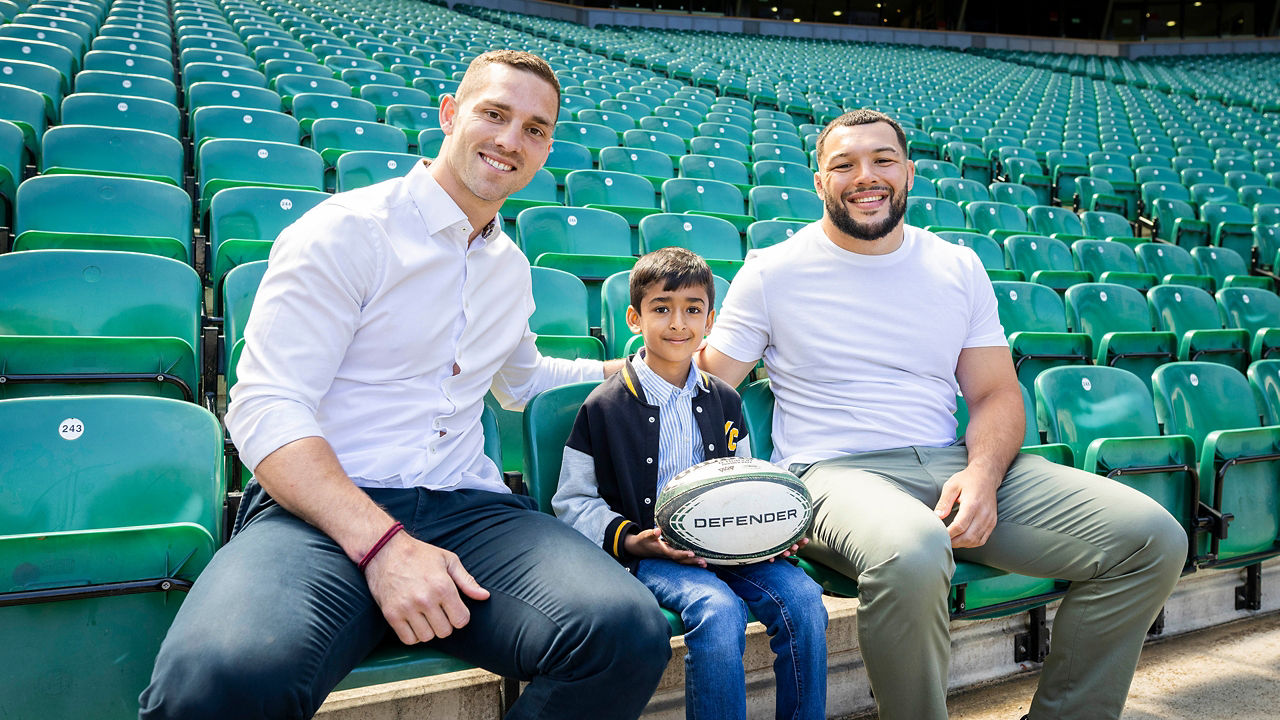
[845,614,1280,720]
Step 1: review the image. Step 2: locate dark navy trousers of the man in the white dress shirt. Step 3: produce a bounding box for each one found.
[140,483,671,720]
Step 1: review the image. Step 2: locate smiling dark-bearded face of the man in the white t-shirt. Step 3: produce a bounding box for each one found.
[813,122,915,254]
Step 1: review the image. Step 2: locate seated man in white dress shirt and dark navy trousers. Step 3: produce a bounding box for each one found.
[141,50,669,720]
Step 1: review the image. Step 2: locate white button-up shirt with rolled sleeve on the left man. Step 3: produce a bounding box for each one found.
[227,164,603,492]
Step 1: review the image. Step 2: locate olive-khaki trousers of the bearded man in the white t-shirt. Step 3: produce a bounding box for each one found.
[801,446,1187,720]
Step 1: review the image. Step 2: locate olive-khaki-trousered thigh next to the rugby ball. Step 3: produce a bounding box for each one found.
[801,450,951,578]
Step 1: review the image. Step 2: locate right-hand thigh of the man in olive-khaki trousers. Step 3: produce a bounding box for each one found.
[956,454,1169,580]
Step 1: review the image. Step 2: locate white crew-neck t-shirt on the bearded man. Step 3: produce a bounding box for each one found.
[708,223,1007,466]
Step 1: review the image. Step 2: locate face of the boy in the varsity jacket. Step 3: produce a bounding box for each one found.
[627,283,716,364]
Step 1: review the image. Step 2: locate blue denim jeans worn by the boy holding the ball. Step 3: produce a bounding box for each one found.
[636,559,827,720]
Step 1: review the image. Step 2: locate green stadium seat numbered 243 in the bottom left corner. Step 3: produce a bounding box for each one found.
[0,397,225,717]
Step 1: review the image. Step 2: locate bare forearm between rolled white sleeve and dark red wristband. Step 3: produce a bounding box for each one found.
[253,437,396,562]
